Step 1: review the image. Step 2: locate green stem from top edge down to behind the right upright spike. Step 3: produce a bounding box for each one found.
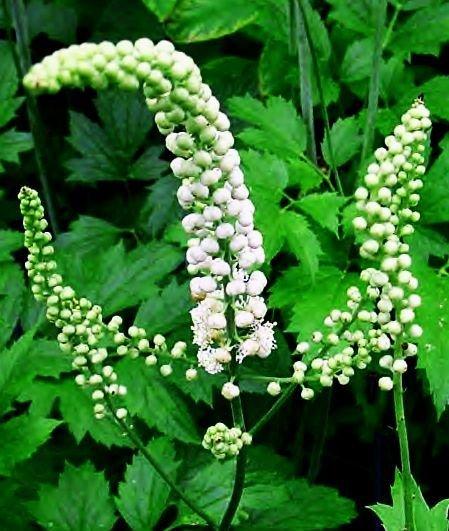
[360,0,387,169]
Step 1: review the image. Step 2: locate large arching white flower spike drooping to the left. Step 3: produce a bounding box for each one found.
[24,38,276,373]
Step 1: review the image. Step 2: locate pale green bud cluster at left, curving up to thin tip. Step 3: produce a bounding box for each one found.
[19,187,184,419]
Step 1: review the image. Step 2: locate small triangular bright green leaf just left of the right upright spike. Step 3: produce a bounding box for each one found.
[296,192,347,234]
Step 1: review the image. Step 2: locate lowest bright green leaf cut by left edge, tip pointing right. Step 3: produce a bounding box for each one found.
[0,414,60,476]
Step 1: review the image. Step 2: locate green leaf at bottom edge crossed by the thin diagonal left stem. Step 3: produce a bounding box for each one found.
[115,437,179,531]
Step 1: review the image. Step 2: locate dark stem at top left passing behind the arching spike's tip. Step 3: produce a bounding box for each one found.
[3,0,59,234]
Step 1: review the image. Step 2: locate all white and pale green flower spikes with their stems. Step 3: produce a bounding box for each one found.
[19,39,431,531]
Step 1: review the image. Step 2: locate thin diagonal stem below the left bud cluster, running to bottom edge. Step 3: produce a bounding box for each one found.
[105,397,217,529]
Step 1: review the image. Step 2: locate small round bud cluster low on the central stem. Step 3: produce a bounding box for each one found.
[202,422,252,460]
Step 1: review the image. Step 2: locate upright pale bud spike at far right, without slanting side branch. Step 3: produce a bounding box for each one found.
[354,100,431,390]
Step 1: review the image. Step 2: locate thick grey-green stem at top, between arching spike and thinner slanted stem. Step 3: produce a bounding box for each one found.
[290,0,317,165]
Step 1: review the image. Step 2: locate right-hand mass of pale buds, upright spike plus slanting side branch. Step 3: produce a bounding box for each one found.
[282,100,431,400]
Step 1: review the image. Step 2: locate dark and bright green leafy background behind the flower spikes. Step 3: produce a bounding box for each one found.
[0,0,449,530]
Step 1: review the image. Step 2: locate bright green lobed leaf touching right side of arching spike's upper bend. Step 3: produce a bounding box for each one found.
[227,96,307,158]
